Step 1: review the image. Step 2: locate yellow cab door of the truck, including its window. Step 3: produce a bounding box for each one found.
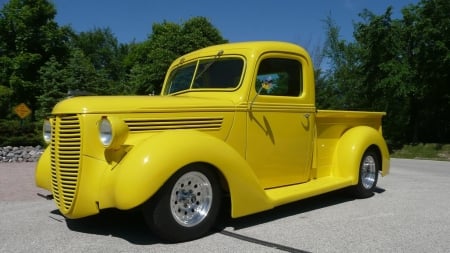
[246,54,315,188]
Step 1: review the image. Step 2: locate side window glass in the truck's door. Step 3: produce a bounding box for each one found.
[255,58,303,97]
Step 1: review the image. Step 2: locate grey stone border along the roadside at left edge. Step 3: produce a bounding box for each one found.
[0,145,44,163]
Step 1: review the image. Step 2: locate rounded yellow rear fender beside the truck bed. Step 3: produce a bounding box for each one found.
[333,126,390,184]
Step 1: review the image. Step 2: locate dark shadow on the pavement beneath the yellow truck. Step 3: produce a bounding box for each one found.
[51,187,385,245]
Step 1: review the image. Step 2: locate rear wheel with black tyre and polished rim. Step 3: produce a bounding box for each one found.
[353,149,381,198]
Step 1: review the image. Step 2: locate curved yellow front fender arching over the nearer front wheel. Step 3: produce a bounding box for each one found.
[106,130,273,217]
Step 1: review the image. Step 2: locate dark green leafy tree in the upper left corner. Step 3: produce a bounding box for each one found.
[0,0,70,120]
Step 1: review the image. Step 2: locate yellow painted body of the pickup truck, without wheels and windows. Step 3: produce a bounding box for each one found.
[36,42,389,218]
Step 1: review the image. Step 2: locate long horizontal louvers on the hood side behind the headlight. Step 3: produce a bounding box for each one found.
[125,117,223,132]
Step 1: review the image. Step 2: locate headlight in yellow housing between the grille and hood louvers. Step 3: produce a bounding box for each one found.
[98,116,128,149]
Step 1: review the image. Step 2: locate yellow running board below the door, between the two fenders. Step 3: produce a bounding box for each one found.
[265,176,352,206]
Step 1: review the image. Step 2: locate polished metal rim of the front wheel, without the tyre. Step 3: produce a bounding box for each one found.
[170,171,213,227]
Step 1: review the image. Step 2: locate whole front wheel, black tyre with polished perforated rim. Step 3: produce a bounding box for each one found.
[143,164,222,242]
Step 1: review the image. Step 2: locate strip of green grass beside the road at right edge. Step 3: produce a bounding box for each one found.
[391,143,450,161]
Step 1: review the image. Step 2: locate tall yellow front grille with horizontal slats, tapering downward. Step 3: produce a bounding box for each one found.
[50,115,81,213]
